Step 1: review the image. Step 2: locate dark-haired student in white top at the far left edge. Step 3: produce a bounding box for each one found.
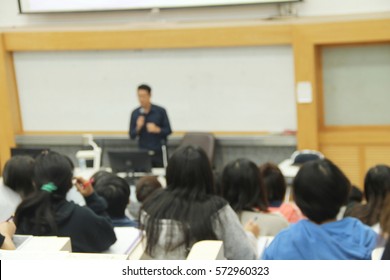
[0,156,34,222]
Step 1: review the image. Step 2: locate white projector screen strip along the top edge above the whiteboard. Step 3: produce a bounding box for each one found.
[19,0,301,13]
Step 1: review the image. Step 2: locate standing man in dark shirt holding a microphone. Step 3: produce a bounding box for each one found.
[129,85,172,167]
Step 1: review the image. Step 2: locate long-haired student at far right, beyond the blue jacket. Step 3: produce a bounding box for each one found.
[344,165,390,233]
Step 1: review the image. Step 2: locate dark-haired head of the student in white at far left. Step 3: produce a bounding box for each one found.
[3,156,35,197]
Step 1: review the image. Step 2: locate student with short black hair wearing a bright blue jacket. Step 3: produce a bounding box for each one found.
[263,159,377,260]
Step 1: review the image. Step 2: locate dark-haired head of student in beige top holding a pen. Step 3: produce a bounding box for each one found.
[222,159,268,212]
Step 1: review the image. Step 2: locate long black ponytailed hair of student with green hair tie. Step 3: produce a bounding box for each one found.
[14,151,73,235]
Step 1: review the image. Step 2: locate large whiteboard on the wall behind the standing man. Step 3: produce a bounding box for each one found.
[14,46,296,132]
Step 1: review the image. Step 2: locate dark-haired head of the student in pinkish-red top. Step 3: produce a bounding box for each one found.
[260,163,287,203]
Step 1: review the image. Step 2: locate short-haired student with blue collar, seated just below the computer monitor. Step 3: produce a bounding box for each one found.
[94,175,138,227]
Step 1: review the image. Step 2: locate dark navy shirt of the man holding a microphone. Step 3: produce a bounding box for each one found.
[129,104,172,153]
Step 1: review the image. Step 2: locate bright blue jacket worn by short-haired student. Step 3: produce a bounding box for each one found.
[263,218,378,260]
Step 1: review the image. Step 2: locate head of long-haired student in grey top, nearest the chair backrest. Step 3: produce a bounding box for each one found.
[166,146,215,197]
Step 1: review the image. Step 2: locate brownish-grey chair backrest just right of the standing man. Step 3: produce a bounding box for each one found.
[179,132,215,165]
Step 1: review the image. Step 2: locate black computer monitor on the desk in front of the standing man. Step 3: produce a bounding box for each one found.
[107,150,152,173]
